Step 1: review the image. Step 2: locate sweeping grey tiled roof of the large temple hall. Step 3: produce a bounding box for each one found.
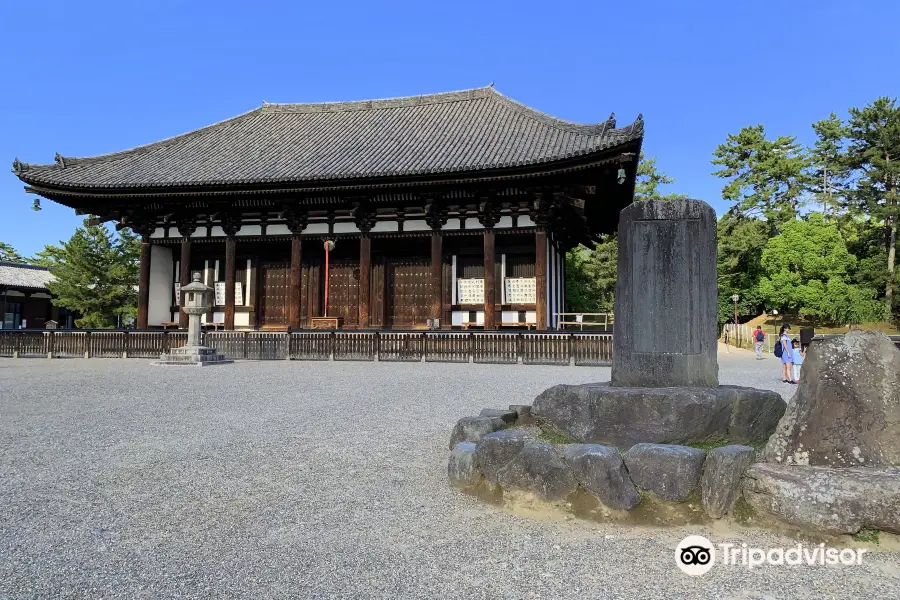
[13,87,644,188]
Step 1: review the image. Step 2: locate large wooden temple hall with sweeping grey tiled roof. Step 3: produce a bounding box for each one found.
[13,87,644,330]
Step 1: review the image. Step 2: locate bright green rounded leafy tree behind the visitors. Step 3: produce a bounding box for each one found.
[759,213,879,323]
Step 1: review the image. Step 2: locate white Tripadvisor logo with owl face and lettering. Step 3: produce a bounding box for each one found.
[675,535,866,577]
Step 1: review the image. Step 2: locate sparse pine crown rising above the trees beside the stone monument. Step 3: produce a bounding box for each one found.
[712,125,811,234]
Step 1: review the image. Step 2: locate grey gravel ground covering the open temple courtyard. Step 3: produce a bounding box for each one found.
[0,352,900,599]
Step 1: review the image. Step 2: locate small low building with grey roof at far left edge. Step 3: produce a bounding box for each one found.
[0,262,72,329]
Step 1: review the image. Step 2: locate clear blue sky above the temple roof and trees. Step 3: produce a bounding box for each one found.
[0,0,900,255]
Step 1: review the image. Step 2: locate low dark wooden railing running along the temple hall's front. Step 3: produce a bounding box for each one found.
[0,329,612,366]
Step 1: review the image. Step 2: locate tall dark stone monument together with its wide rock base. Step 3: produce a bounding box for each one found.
[531,200,785,449]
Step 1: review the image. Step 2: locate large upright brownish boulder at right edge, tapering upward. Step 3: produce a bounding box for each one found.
[765,331,900,467]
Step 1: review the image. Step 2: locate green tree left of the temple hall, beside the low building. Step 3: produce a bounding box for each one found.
[38,220,139,328]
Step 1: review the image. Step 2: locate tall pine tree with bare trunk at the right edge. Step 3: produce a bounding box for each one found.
[847,97,900,319]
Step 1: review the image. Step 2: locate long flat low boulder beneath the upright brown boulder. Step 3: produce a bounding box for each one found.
[742,463,900,535]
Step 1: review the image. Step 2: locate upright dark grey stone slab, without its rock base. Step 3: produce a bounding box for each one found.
[612,200,719,387]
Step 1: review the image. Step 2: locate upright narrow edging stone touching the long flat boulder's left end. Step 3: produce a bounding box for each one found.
[700,446,756,519]
